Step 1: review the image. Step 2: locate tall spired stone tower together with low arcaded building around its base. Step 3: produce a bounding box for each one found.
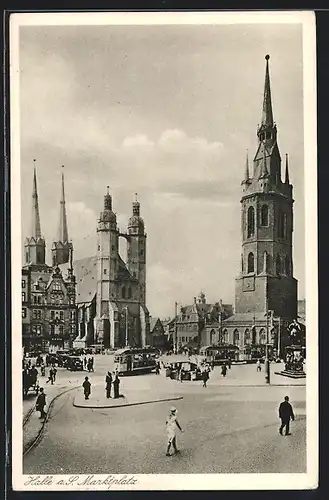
[222,56,297,357]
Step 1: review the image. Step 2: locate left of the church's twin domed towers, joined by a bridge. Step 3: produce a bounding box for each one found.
[95,186,119,347]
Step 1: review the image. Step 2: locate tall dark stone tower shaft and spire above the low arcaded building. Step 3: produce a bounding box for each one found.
[235,55,297,319]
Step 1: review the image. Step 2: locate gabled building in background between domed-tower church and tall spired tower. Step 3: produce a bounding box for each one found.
[171,292,233,351]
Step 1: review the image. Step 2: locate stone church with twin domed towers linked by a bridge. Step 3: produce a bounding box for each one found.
[60,188,150,348]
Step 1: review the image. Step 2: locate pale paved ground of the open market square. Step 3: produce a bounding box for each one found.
[24,356,306,474]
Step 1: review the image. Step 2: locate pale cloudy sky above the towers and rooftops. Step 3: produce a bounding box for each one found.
[20,20,304,316]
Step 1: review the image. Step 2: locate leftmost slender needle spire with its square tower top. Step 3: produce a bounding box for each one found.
[24,160,46,265]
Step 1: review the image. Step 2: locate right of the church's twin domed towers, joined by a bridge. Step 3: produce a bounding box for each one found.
[127,195,146,306]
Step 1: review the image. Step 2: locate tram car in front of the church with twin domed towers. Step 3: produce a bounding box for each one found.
[114,347,159,375]
